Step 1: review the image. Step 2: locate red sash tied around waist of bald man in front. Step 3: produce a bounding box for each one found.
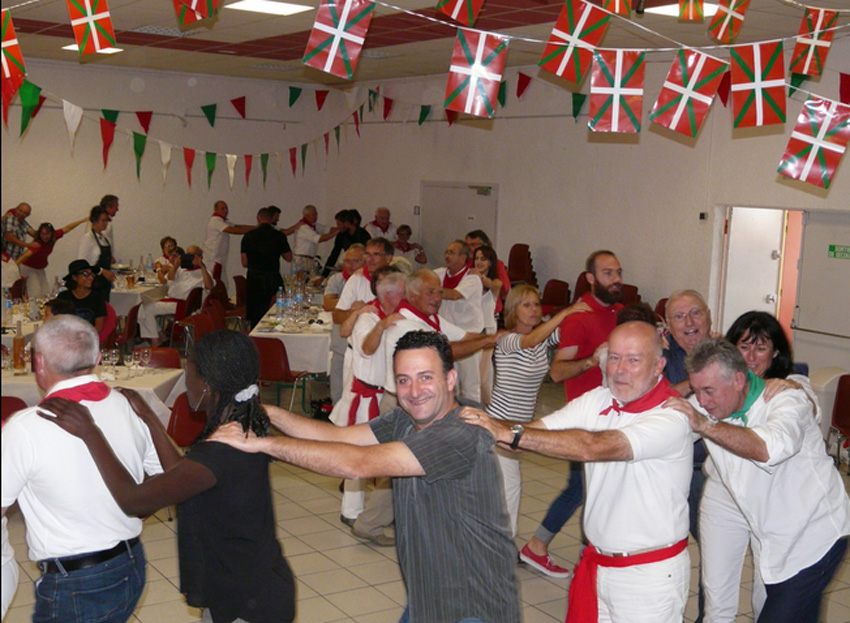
[566,538,688,623]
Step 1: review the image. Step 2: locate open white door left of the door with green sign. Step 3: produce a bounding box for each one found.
[720,207,785,333]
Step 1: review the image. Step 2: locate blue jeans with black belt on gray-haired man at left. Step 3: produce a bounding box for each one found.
[32,542,145,623]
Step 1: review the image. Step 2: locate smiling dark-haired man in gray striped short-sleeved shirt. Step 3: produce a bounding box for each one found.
[210,331,520,623]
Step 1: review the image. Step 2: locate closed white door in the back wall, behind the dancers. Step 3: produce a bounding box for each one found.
[420,182,496,267]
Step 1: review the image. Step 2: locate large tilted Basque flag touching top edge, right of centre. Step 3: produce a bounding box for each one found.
[537,0,611,84]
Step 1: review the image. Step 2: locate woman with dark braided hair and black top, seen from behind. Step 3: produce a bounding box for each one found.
[42,329,295,623]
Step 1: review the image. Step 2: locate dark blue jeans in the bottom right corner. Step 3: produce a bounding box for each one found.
[757,537,847,623]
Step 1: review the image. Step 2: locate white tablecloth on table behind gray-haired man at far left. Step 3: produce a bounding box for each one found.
[3,366,186,426]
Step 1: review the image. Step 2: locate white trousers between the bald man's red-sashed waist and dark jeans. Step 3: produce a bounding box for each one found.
[699,477,767,623]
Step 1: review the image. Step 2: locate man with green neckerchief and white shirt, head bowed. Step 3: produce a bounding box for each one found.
[671,338,850,623]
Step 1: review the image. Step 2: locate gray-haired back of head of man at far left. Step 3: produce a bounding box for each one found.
[33,314,100,376]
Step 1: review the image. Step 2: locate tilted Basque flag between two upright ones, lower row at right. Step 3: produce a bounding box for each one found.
[649,49,728,137]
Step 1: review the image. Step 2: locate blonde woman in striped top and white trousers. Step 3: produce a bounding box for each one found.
[487,285,590,535]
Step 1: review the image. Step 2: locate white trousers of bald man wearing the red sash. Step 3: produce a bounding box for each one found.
[596,548,691,623]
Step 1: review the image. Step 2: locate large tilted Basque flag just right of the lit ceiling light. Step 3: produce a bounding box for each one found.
[303,0,375,80]
